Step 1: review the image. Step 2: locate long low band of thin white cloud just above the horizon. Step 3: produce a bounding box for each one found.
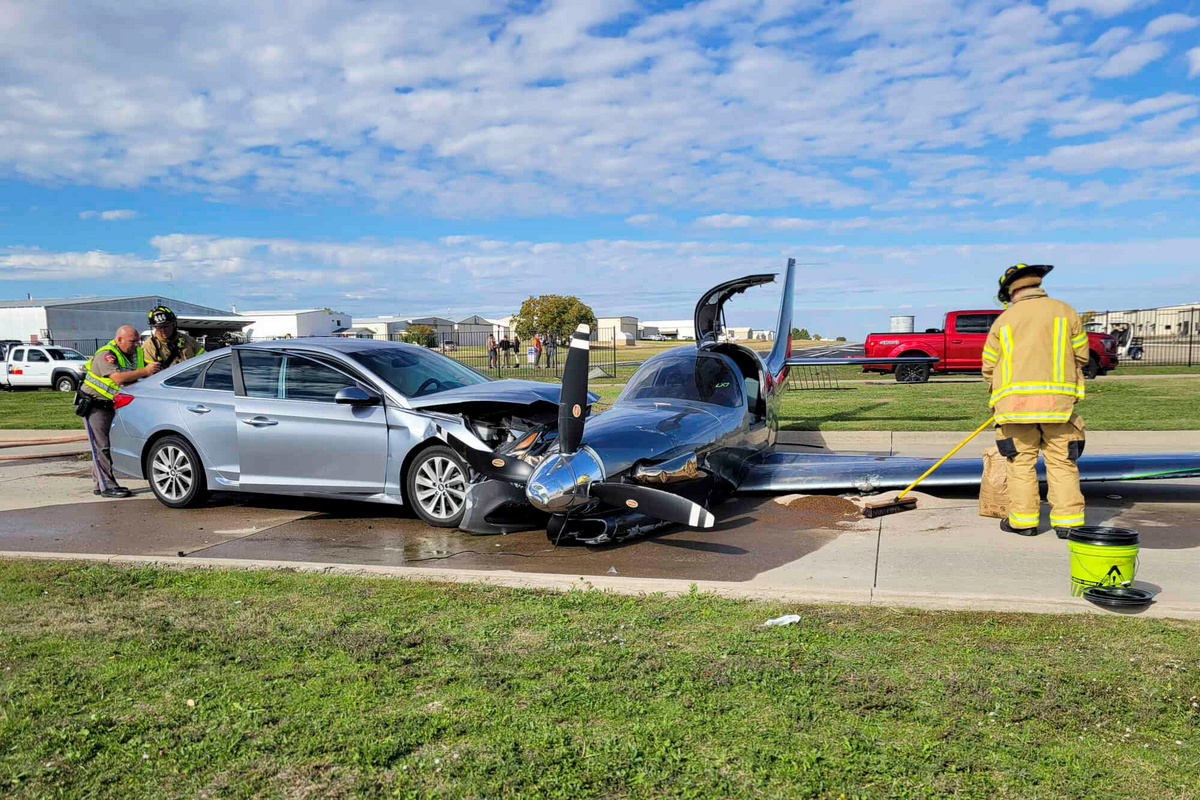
[11,231,1200,333]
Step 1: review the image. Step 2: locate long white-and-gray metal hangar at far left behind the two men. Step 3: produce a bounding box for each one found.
[0,295,254,350]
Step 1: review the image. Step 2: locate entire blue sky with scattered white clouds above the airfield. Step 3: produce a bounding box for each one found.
[0,0,1200,337]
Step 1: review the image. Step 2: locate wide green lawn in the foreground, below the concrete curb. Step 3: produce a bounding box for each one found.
[0,563,1200,800]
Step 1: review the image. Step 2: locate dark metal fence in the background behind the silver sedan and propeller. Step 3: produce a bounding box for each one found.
[49,329,617,380]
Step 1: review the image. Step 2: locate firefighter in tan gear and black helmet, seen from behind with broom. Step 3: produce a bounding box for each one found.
[983,264,1088,539]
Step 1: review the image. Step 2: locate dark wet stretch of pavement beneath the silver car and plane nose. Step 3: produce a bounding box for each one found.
[0,494,874,581]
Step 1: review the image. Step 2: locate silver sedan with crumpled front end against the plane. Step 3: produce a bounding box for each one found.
[112,337,594,527]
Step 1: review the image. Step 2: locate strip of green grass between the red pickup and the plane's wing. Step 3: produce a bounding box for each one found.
[780,378,1200,431]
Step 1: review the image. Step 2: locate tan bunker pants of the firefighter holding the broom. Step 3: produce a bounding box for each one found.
[996,416,1084,528]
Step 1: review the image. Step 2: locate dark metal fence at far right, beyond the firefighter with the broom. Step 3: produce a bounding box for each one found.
[1084,305,1200,369]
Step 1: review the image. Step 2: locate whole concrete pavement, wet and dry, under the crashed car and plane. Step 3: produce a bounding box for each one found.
[0,432,1200,619]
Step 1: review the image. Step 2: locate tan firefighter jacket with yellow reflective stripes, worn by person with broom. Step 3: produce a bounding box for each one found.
[983,289,1090,423]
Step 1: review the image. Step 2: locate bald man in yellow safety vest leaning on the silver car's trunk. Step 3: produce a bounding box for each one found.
[76,325,162,498]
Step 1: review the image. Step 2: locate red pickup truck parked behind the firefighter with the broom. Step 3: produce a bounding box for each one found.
[863,308,1117,384]
